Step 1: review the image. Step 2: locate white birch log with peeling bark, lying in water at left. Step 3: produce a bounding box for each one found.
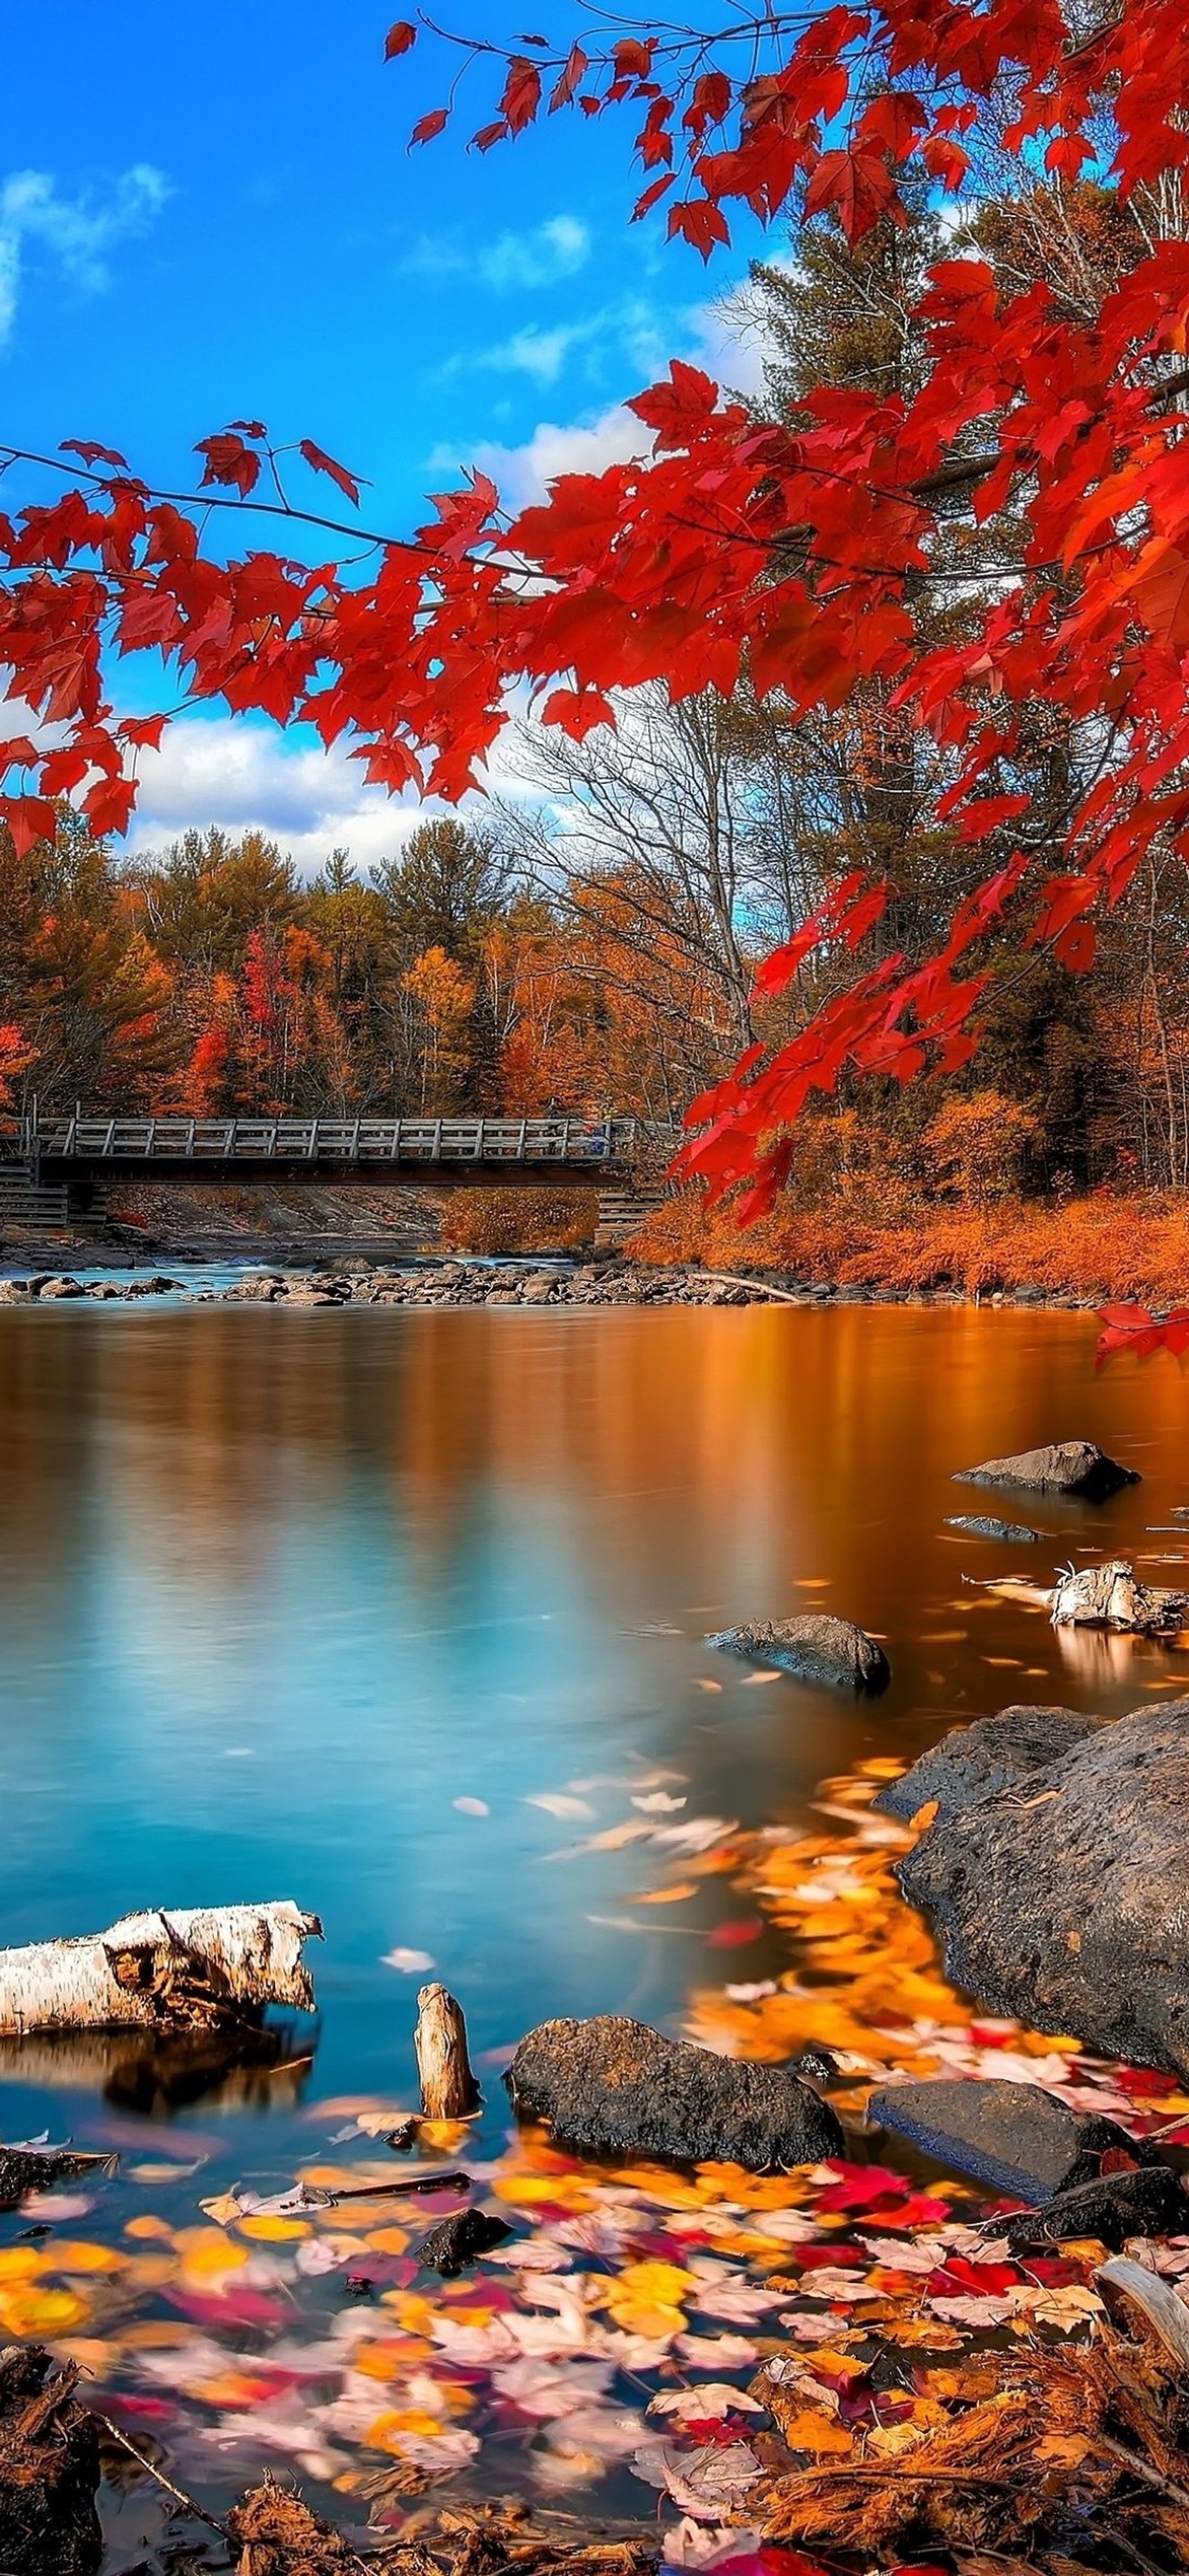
[0,1901,322,2038]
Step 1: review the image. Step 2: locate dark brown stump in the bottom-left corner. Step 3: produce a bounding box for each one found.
[0,2344,103,2576]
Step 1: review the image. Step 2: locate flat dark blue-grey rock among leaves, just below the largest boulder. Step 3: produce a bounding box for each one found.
[867,2076,1150,2233]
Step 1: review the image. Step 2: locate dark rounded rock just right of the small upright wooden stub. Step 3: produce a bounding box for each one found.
[507,2012,844,2174]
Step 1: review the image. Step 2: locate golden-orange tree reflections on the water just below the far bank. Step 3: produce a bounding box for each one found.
[0,1308,1187,1688]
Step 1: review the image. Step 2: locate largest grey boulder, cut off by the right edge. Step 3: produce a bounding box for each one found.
[898,1700,1189,2076]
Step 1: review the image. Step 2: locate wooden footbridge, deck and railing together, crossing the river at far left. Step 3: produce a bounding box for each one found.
[18,1115,651,1190]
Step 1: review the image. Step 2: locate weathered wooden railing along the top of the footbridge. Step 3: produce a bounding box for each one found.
[23,1113,651,1167]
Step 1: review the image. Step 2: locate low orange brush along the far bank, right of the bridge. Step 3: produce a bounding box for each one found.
[628,1190,1189,1306]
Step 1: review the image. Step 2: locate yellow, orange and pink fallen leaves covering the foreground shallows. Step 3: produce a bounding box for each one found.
[11,1760,1189,2576]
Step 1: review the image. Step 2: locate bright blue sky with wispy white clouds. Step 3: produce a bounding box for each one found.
[0,0,771,865]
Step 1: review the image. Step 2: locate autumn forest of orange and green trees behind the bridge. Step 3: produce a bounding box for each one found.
[0,198,1189,1256]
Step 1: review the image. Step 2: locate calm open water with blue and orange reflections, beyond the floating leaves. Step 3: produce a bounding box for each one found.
[0,1306,1189,2555]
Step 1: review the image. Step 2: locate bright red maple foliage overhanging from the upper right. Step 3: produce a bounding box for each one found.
[0,0,1189,1247]
